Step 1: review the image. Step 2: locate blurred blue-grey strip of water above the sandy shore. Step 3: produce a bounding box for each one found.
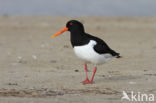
[0,0,156,16]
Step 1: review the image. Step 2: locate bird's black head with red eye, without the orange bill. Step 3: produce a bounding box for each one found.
[66,20,84,32]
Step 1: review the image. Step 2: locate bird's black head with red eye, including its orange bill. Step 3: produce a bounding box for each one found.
[51,20,84,37]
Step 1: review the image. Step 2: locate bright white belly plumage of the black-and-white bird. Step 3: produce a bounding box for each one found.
[74,40,112,64]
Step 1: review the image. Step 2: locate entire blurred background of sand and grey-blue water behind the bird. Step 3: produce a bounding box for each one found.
[0,0,156,103]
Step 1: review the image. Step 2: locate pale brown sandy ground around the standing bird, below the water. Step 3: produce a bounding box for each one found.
[0,17,156,103]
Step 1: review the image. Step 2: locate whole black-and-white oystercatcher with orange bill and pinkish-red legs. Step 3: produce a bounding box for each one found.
[51,20,121,84]
